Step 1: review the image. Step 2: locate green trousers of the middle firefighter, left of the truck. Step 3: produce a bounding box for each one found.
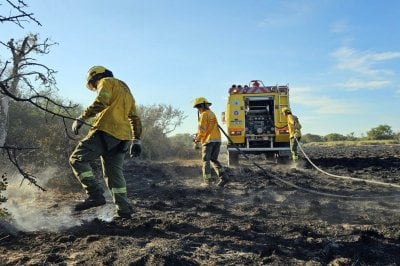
[201,142,225,181]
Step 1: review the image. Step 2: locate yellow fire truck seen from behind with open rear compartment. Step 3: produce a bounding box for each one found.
[222,80,290,165]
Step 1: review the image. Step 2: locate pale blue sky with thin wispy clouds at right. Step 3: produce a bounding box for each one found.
[0,0,400,136]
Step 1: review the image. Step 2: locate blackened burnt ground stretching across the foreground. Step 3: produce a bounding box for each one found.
[0,145,400,265]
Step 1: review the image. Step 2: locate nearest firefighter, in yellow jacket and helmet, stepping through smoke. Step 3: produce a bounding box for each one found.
[69,66,142,218]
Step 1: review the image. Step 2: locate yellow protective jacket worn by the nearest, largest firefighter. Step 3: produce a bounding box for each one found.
[79,77,142,140]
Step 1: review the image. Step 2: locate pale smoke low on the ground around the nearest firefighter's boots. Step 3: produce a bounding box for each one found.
[3,167,114,232]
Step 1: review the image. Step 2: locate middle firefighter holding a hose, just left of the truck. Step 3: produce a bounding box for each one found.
[193,97,228,187]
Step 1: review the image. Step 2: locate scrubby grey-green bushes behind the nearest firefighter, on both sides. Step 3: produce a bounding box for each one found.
[2,102,197,167]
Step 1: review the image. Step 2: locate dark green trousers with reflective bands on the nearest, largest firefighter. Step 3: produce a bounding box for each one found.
[69,130,132,212]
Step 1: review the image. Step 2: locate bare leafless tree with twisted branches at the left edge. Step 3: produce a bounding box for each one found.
[0,0,75,189]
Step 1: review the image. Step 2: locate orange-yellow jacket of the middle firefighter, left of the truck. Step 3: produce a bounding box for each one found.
[196,110,221,144]
